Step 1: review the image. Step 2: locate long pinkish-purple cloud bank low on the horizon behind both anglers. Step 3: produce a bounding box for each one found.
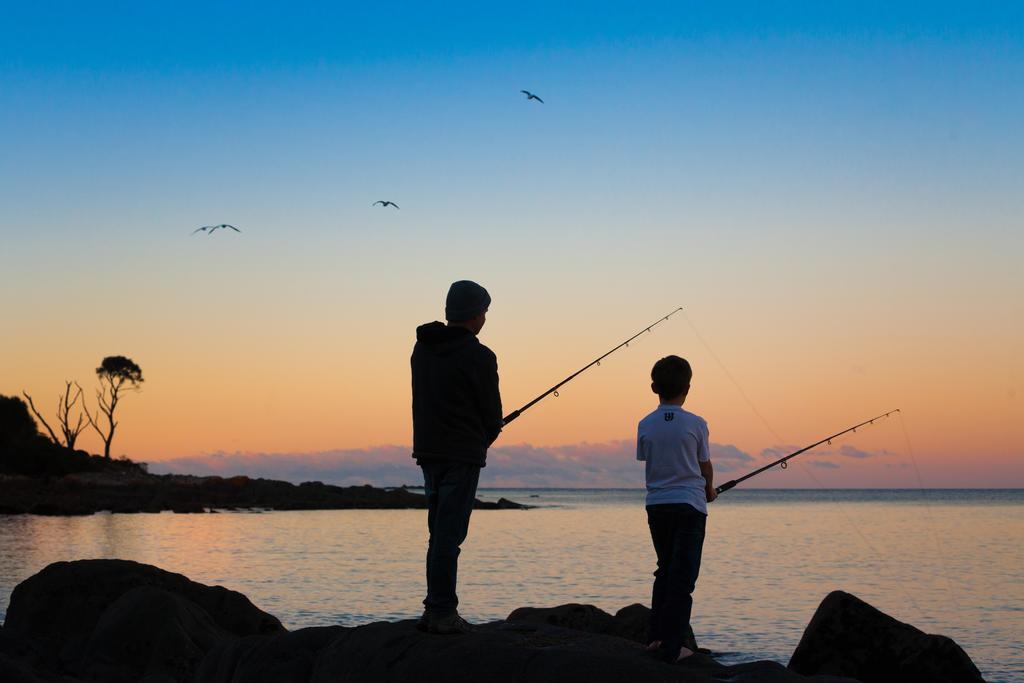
[150,439,754,488]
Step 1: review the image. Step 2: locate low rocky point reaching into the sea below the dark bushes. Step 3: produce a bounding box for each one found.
[0,468,529,515]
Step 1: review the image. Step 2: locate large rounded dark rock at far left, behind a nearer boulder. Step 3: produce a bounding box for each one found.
[4,560,285,667]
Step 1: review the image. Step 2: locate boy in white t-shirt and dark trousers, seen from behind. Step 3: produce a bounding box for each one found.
[637,355,717,661]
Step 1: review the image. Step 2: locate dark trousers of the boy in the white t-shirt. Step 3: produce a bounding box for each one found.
[647,504,708,652]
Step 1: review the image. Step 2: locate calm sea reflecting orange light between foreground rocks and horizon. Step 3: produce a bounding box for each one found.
[0,489,1024,681]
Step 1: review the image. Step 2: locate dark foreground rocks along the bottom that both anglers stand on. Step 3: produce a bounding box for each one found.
[0,560,982,683]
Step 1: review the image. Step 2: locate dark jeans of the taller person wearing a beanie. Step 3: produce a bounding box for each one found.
[420,463,480,614]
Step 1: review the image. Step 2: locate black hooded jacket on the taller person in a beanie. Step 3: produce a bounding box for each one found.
[412,322,502,467]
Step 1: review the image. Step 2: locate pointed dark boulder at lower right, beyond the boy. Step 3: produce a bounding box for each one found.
[790,591,983,683]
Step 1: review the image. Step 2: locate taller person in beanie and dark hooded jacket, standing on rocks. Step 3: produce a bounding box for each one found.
[412,280,502,634]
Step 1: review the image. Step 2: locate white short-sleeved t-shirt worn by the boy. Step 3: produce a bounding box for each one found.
[637,403,711,514]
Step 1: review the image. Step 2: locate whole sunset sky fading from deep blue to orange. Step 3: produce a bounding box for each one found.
[0,2,1024,487]
